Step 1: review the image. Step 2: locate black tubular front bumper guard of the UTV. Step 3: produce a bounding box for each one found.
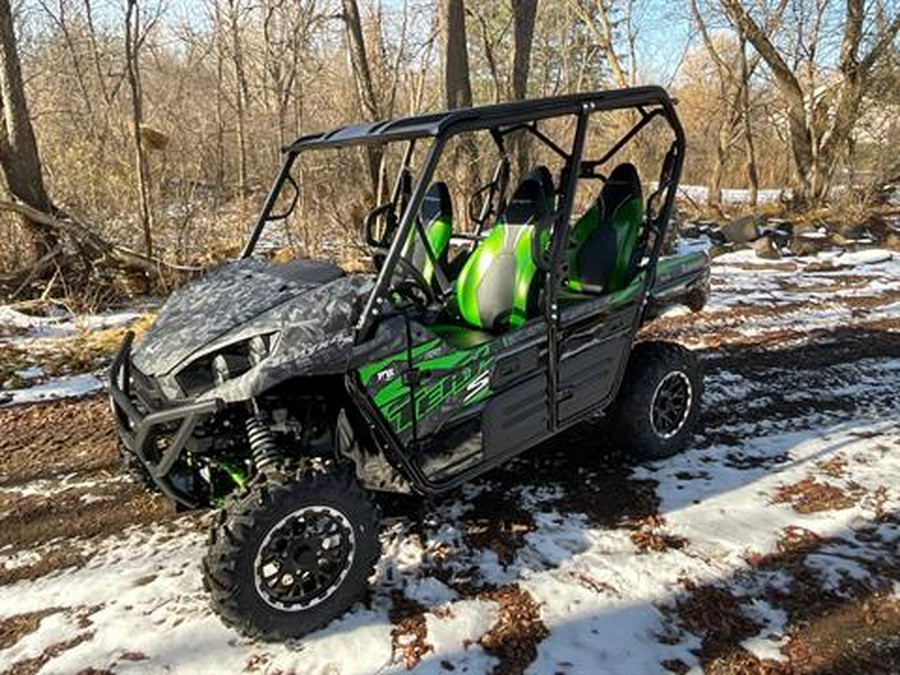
[109,331,224,508]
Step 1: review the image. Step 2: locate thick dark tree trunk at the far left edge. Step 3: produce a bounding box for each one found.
[0,0,59,259]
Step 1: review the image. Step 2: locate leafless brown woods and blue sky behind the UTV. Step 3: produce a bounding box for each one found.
[0,0,900,297]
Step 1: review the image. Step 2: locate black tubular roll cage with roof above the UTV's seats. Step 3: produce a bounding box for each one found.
[241,86,685,342]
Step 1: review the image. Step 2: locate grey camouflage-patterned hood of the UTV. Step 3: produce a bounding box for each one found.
[133,259,356,376]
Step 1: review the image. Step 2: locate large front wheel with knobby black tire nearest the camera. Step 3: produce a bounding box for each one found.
[203,471,380,641]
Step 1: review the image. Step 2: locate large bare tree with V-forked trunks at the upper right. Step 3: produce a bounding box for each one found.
[721,0,900,204]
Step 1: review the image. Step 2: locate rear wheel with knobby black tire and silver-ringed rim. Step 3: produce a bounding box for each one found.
[609,342,703,459]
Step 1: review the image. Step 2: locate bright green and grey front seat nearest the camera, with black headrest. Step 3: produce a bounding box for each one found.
[456,178,548,333]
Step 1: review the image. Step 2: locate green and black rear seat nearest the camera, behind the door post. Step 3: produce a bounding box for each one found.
[569,164,644,292]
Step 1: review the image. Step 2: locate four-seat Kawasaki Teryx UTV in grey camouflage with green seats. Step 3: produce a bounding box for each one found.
[110,87,709,640]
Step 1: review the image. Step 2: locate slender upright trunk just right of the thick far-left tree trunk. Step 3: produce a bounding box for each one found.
[125,0,153,256]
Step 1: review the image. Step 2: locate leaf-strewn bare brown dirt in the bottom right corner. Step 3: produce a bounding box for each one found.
[676,516,900,675]
